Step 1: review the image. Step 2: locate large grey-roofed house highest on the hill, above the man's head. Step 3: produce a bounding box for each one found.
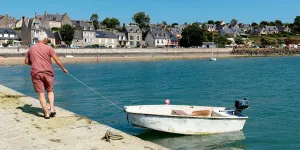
[35,12,72,29]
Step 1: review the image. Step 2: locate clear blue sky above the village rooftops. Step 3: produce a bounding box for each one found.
[0,0,300,24]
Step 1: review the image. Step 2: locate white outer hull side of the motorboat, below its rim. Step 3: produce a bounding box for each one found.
[128,113,247,135]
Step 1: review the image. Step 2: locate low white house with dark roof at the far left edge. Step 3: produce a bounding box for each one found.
[0,28,19,45]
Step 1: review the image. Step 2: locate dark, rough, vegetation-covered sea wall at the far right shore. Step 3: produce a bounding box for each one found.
[231,48,300,56]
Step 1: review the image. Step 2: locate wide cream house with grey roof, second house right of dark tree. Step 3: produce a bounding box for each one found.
[95,31,119,48]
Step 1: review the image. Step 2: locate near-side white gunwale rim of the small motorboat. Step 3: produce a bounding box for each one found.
[125,110,248,120]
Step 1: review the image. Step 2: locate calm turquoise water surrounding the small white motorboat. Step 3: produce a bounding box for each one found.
[0,57,300,150]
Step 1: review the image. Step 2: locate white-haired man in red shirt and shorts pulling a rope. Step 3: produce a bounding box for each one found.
[25,34,68,119]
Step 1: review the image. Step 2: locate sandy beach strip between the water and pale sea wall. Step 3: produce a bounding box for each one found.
[0,54,247,66]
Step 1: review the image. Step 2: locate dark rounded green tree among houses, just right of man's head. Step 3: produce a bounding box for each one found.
[60,24,75,46]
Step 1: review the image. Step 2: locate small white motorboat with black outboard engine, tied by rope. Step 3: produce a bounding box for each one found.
[125,99,248,135]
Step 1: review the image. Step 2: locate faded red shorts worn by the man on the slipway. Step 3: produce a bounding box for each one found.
[32,72,54,93]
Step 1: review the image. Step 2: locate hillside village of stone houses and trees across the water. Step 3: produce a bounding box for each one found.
[0,12,300,48]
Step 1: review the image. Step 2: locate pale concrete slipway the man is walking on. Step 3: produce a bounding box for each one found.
[0,84,166,150]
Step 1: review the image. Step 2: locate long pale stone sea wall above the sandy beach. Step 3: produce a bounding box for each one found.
[0,48,232,57]
